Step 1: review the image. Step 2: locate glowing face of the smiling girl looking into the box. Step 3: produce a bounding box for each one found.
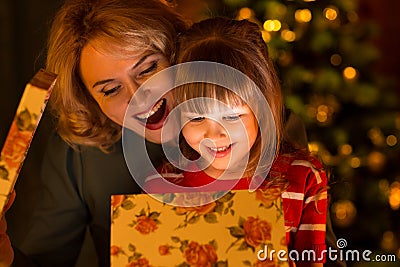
[181,105,258,178]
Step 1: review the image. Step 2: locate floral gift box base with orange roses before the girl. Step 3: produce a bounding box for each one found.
[110,190,289,267]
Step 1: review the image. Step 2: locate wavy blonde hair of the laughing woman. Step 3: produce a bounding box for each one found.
[47,0,188,151]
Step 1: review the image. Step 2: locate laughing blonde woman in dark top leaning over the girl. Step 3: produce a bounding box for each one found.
[11,0,188,266]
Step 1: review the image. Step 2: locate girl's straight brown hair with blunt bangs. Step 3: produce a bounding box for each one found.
[175,17,283,175]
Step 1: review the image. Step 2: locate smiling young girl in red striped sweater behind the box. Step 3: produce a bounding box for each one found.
[144,18,327,266]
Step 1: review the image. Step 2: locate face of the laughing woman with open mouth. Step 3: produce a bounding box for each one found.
[80,43,173,143]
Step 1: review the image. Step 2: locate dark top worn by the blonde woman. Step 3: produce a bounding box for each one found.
[16,131,161,267]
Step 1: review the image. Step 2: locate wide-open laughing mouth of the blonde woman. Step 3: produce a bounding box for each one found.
[134,98,169,130]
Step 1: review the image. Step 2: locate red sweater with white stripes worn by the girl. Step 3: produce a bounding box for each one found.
[144,152,327,266]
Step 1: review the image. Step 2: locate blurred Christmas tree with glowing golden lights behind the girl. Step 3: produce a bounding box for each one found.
[182,0,400,266]
